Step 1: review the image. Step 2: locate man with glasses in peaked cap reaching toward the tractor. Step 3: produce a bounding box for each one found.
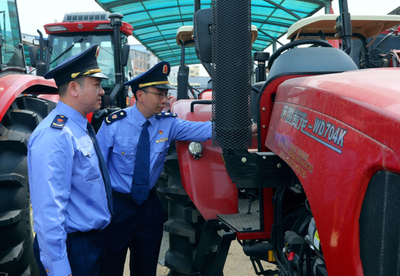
[97,62,212,276]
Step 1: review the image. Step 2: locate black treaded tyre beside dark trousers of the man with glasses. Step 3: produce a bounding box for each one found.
[158,143,225,276]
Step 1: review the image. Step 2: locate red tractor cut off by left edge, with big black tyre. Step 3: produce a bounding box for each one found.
[0,0,57,276]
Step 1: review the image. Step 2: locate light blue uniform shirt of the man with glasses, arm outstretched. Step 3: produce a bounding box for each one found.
[97,105,212,194]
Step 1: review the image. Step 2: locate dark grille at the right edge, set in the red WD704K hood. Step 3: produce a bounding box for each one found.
[360,171,400,276]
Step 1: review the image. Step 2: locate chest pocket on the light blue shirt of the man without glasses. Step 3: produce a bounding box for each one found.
[77,146,101,182]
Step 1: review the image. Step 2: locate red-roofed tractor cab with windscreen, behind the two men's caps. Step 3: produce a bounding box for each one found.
[30,12,134,130]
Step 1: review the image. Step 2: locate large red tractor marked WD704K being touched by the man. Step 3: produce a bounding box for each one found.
[158,0,400,276]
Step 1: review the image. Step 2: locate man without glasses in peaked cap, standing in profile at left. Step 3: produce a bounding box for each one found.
[28,44,112,276]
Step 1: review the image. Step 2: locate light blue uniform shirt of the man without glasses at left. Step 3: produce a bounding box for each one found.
[28,102,111,276]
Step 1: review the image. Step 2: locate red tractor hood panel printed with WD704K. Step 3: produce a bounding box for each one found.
[265,69,400,275]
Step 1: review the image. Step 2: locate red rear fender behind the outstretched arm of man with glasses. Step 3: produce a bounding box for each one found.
[171,100,238,220]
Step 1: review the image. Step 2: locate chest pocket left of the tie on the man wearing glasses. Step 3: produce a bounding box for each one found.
[112,144,136,174]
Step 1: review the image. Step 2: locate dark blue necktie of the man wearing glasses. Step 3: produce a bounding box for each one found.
[131,121,150,205]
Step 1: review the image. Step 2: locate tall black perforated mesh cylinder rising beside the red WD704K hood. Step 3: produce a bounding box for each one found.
[211,0,252,149]
